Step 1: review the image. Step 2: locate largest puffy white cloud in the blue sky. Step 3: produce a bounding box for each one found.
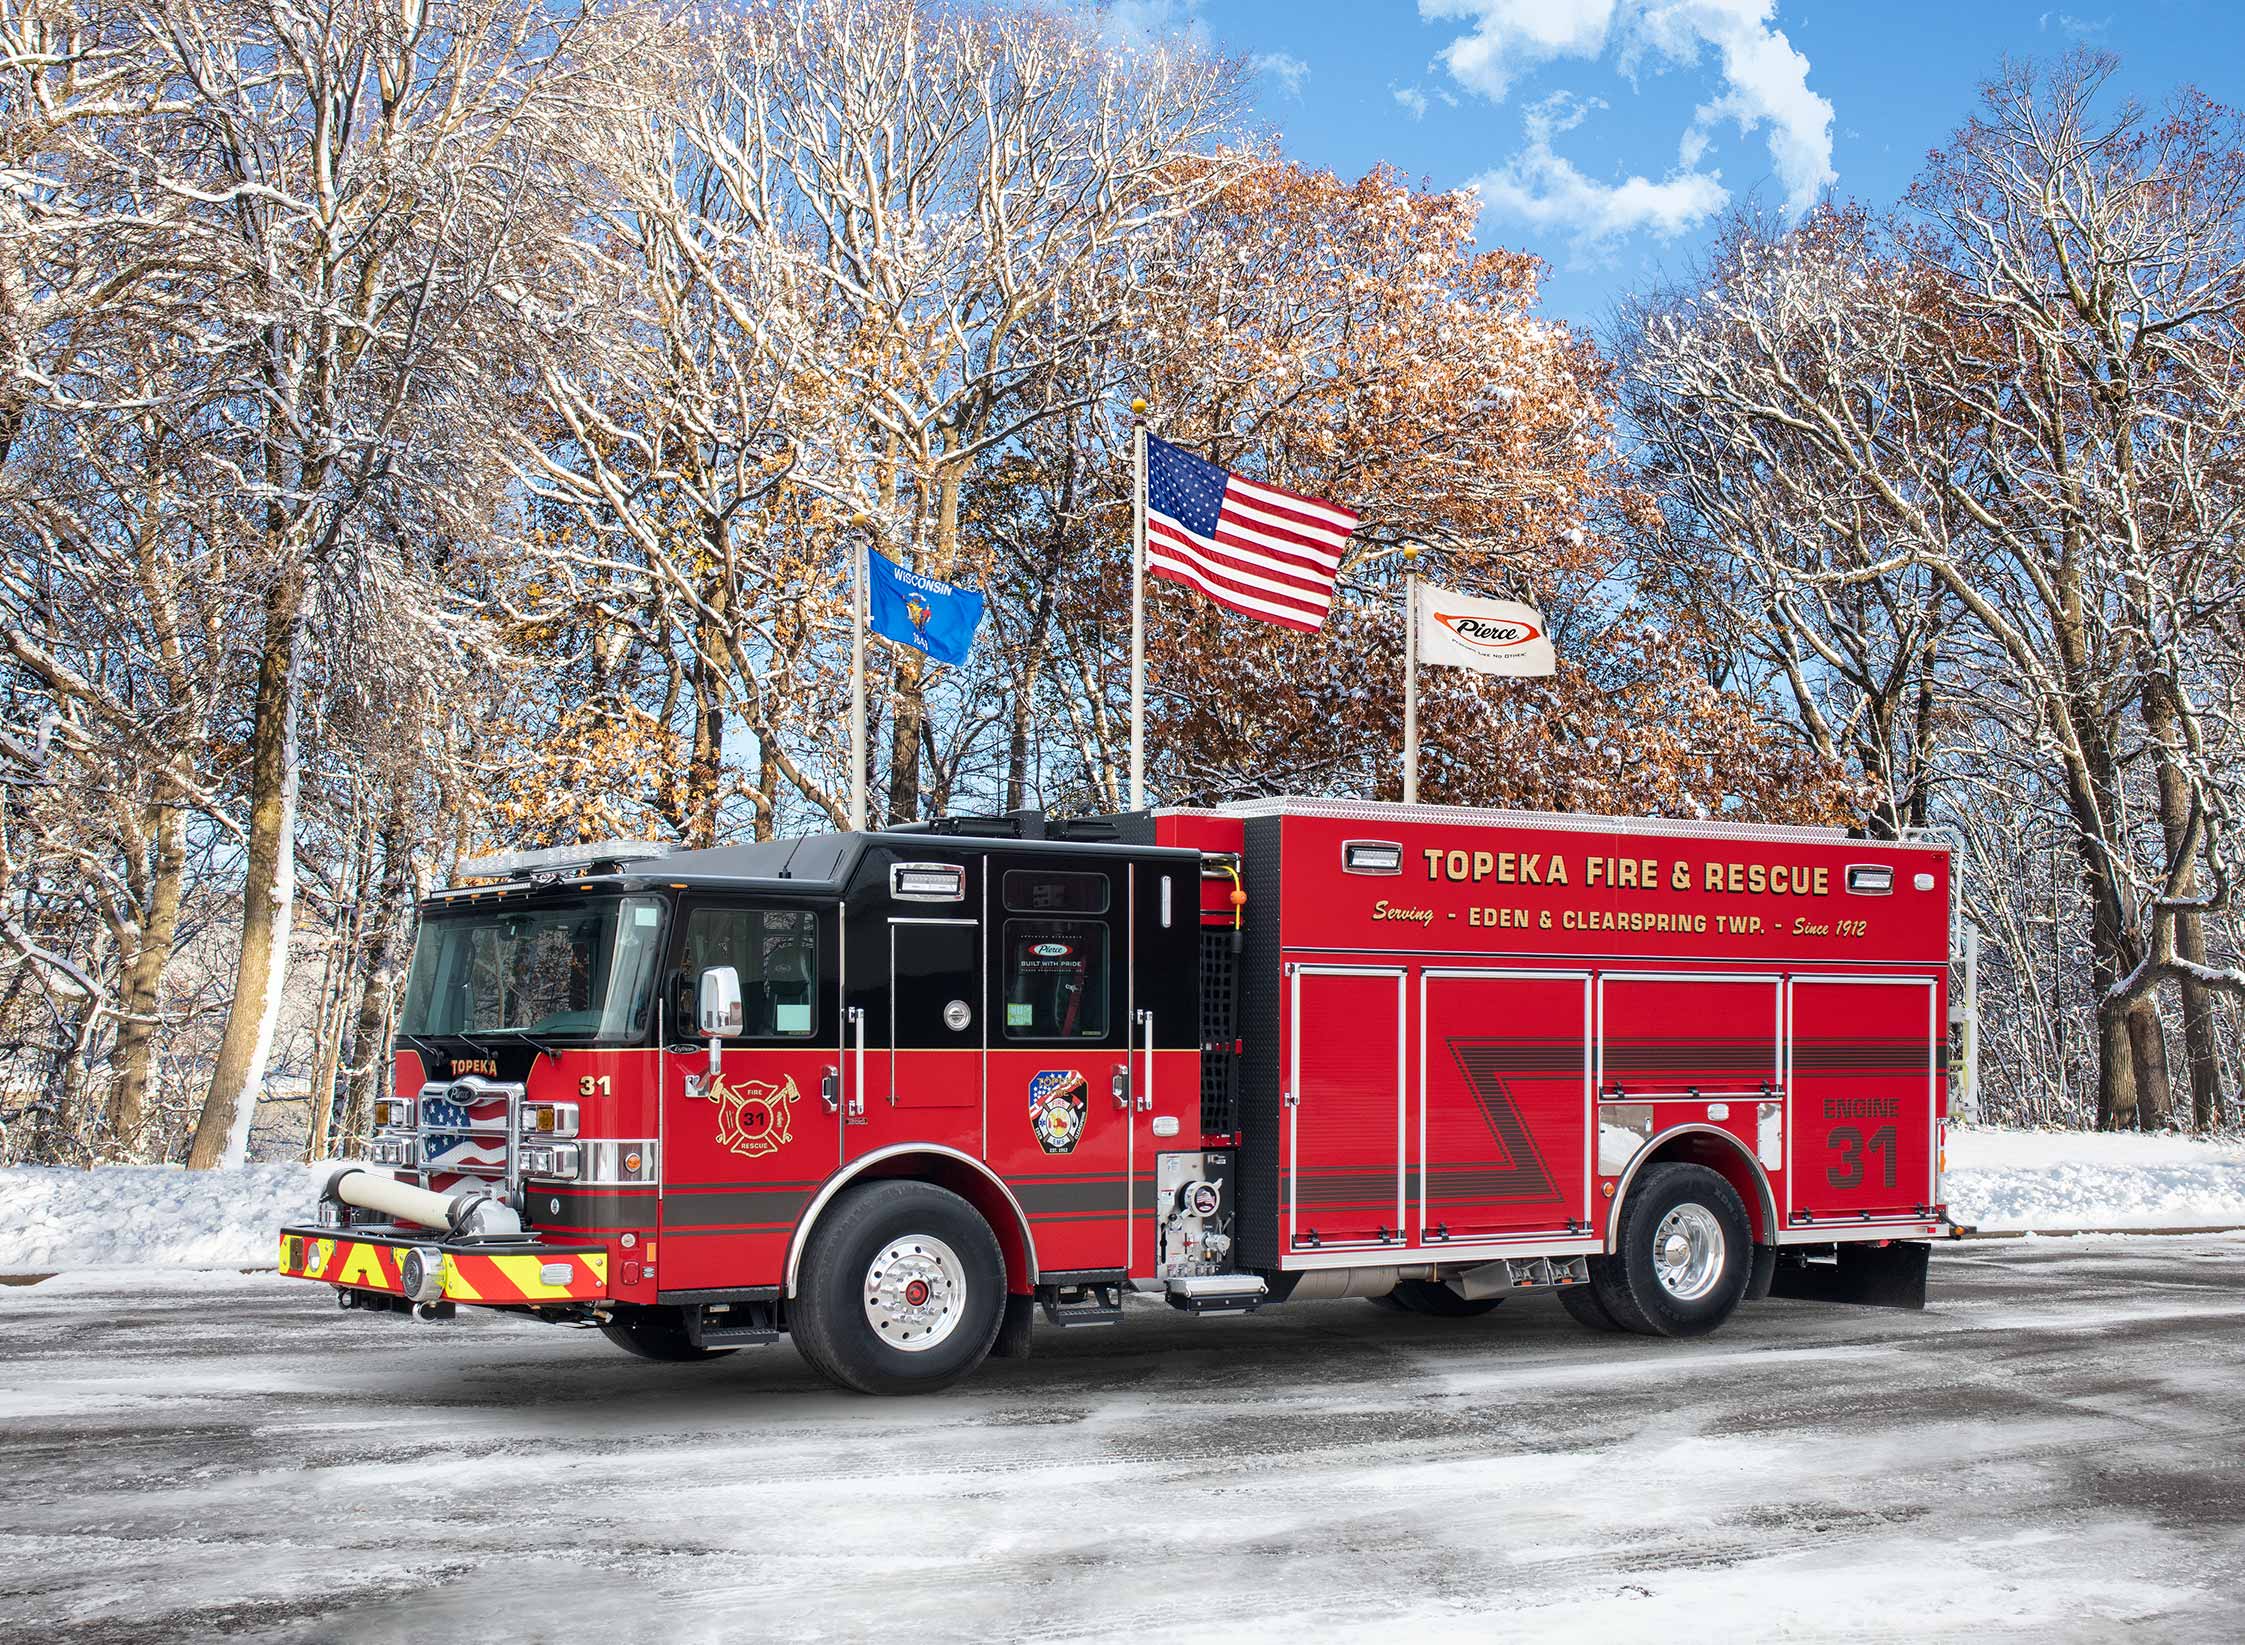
[1419,0,1836,238]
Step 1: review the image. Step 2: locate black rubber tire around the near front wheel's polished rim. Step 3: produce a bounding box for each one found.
[788,1183,1006,1394]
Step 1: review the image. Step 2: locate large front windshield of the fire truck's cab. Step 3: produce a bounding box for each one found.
[397,898,662,1044]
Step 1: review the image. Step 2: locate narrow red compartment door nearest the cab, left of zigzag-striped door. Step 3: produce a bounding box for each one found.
[1286,965,1405,1250]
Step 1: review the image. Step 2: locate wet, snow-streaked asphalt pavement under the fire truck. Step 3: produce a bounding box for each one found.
[0,1237,2245,1645]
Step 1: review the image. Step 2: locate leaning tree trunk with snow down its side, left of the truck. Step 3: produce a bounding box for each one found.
[186,566,308,1171]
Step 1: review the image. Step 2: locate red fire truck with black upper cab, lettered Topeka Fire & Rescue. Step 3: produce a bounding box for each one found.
[281,799,1951,1391]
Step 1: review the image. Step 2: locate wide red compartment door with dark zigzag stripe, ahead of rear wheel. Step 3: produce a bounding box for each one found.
[1417,969,1592,1246]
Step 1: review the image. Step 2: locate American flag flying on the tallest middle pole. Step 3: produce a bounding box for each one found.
[1145,435,1356,633]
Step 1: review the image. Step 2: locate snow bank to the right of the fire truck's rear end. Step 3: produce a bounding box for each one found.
[1949,1127,2245,1230]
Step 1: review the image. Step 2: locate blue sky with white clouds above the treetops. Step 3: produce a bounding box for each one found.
[1109,0,2245,325]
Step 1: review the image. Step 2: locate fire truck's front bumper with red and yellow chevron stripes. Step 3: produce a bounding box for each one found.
[278,1228,608,1308]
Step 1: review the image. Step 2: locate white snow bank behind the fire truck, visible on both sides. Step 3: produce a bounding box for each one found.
[0,1129,2245,1275]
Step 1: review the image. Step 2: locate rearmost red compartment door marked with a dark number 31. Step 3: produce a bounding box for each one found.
[1785,976,1942,1219]
